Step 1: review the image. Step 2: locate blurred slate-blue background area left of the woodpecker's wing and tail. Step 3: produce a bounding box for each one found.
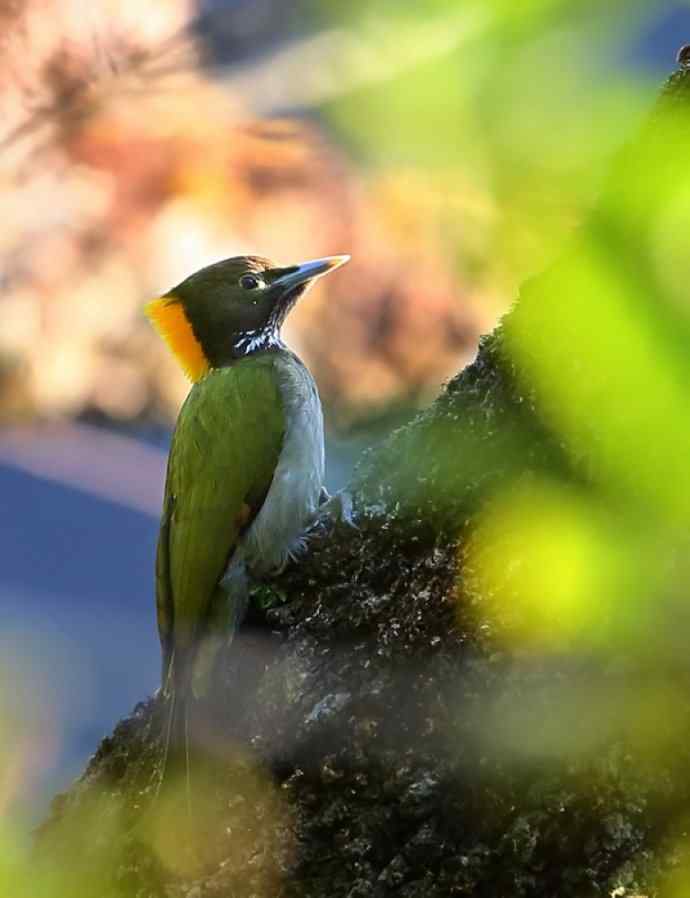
[0,458,159,816]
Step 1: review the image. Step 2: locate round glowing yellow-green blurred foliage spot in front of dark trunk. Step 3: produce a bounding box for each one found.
[474,481,665,651]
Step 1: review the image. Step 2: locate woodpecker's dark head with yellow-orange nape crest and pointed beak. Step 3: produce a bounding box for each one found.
[145,256,350,381]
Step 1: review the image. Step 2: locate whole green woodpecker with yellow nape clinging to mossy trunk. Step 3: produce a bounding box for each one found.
[145,255,350,774]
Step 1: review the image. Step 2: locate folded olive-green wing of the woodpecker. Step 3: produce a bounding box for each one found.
[157,355,285,652]
